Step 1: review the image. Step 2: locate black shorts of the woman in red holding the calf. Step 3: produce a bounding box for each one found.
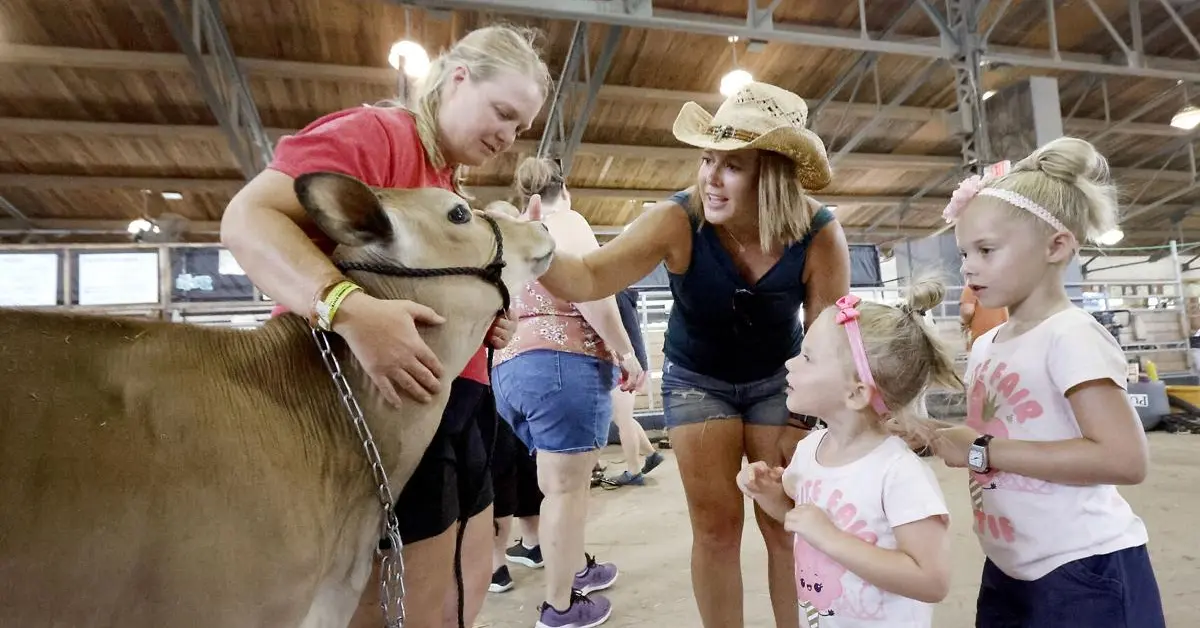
[396,377,499,545]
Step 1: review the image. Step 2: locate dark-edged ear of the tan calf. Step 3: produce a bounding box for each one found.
[295,172,394,246]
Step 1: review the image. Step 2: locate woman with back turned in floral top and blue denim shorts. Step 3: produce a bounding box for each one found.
[492,157,643,628]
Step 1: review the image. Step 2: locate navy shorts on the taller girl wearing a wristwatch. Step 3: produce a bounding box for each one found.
[976,545,1166,628]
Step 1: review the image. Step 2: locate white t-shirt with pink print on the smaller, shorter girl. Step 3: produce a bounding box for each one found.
[784,430,949,628]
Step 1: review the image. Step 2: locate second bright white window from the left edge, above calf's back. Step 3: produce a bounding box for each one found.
[78,253,158,305]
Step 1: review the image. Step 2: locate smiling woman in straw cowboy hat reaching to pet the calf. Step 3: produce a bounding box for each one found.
[528,83,850,628]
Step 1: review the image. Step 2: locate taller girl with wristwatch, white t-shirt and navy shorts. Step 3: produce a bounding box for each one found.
[934,138,1165,628]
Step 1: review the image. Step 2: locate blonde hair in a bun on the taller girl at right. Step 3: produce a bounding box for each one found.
[986,137,1117,243]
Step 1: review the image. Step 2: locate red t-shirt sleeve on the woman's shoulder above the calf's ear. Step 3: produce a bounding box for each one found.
[269,107,393,187]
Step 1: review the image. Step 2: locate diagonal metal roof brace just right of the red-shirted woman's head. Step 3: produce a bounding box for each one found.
[538,22,623,175]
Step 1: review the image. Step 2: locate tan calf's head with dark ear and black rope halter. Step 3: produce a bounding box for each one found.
[295,172,554,306]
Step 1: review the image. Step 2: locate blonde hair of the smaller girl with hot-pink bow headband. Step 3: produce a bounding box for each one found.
[833,275,964,444]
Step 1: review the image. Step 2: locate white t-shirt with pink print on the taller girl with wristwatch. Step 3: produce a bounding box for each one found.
[966,307,1147,580]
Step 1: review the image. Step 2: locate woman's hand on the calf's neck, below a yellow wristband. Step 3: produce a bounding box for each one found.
[334,292,445,406]
